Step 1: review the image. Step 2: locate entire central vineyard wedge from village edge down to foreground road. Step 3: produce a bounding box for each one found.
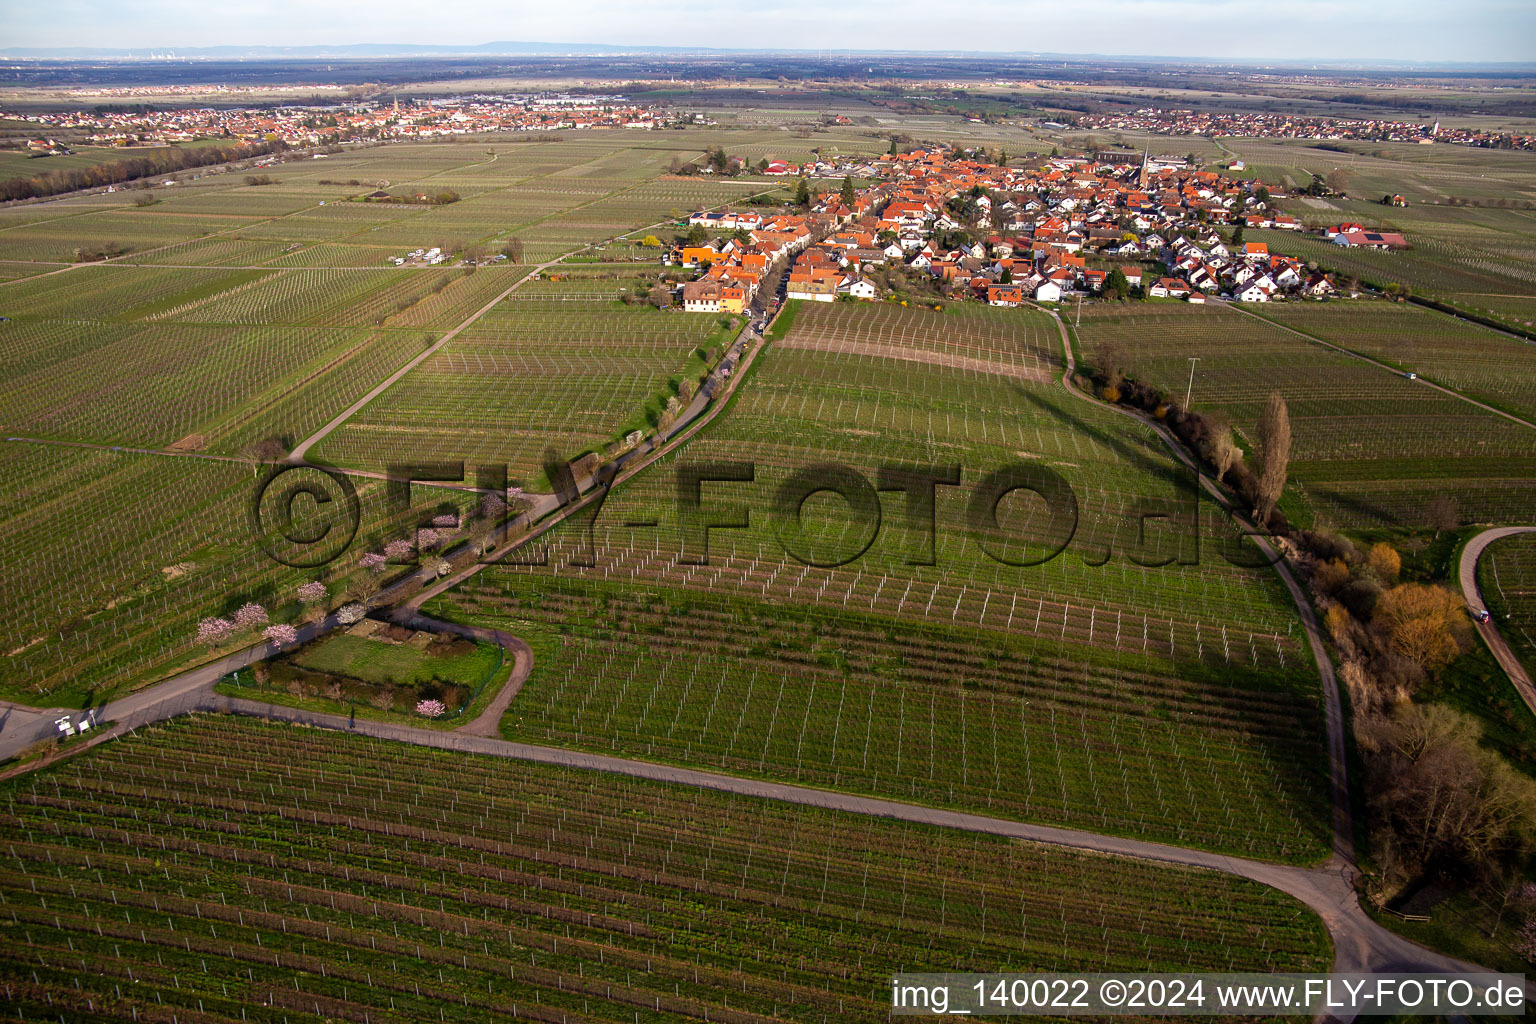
[420,306,1326,861]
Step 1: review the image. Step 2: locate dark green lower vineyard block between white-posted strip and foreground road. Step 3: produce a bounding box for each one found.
[429,570,1327,863]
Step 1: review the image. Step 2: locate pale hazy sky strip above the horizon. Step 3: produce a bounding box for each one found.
[9,0,1536,61]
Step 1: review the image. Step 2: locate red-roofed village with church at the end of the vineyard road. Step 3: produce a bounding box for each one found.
[664,149,1382,313]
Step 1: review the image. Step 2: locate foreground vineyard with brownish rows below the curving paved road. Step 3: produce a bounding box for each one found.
[0,717,1330,1024]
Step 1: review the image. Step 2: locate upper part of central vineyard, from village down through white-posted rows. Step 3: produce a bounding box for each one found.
[562,304,1301,654]
